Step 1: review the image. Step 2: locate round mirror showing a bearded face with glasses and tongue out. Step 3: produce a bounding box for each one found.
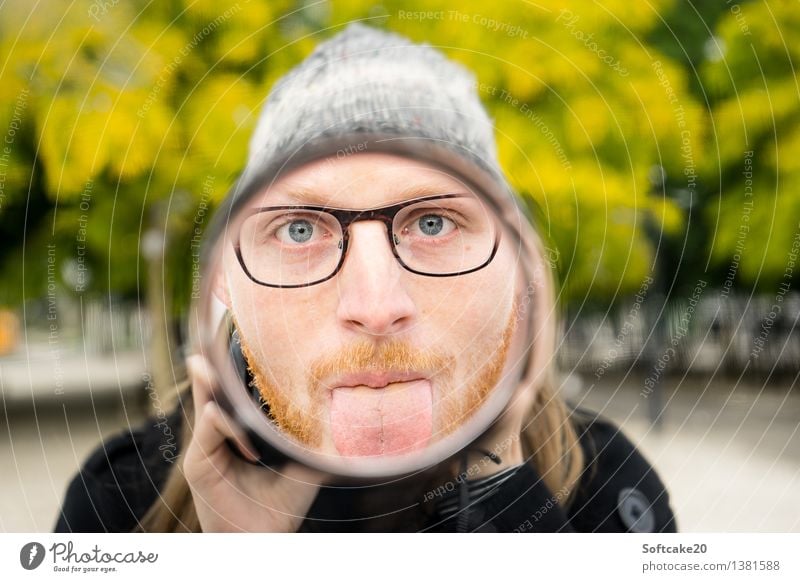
[191,135,532,478]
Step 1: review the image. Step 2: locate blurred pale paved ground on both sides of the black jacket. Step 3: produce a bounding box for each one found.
[0,364,800,532]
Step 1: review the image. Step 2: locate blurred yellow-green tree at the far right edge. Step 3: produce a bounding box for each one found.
[700,1,800,293]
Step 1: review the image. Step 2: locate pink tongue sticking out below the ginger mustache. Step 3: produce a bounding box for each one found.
[330,380,433,457]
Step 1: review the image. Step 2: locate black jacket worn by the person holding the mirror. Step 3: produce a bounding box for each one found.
[55,409,676,532]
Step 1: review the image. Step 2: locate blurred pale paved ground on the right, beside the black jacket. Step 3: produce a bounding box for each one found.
[577,379,800,532]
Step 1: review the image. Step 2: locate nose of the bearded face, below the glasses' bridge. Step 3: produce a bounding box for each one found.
[337,220,417,335]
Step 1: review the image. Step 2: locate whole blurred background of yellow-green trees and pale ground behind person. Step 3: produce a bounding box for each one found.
[0,0,800,532]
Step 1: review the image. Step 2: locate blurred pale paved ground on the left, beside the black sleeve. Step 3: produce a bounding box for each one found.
[0,343,153,532]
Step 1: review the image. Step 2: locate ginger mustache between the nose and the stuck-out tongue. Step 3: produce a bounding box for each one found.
[308,340,456,393]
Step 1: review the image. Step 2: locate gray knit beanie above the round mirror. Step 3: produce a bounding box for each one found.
[241,23,507,192]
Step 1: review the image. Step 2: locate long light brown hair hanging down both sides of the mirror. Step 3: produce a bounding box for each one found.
[134,219,584,532]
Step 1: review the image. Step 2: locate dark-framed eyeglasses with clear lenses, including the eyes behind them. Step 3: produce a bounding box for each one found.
[233,193,500,288]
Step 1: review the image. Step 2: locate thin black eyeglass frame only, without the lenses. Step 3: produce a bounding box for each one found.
[232,192,502,289]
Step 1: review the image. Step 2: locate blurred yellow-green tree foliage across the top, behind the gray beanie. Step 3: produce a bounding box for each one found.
[0,0,800,300]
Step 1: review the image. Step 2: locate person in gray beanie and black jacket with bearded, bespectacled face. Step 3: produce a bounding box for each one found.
[56,24,675,531]
